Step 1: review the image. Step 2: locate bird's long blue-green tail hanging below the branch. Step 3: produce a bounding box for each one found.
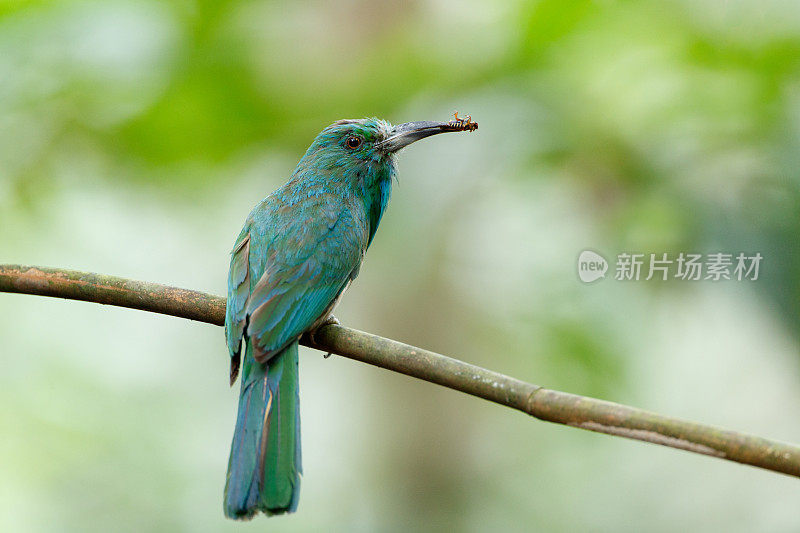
[225,342,301,519]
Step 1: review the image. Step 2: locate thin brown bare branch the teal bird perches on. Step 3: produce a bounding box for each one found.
[0,265,800,477]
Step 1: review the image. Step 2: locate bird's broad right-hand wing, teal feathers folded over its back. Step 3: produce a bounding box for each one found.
[246,197,369,363]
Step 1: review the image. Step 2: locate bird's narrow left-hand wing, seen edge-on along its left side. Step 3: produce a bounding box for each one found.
[225,223,250,384]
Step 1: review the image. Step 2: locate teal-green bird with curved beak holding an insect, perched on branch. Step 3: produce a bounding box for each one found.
[224,118,477,520]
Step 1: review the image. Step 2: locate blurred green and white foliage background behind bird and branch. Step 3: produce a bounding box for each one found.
[0,0,800,532]
